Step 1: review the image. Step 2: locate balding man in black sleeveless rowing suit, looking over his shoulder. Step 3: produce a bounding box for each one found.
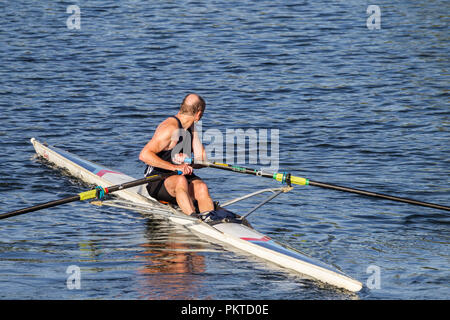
[139,94,214,217]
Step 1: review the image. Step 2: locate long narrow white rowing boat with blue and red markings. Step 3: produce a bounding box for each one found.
[31,138,362,292]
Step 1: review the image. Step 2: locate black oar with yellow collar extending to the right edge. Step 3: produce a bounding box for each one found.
[188,160,450,211]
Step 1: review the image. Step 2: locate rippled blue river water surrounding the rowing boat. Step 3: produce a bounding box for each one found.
[0,0,450,300]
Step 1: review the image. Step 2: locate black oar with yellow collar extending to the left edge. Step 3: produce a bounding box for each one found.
[0,171,180,219]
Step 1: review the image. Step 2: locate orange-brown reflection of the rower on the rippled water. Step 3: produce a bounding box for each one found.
[138,218,211,300]
